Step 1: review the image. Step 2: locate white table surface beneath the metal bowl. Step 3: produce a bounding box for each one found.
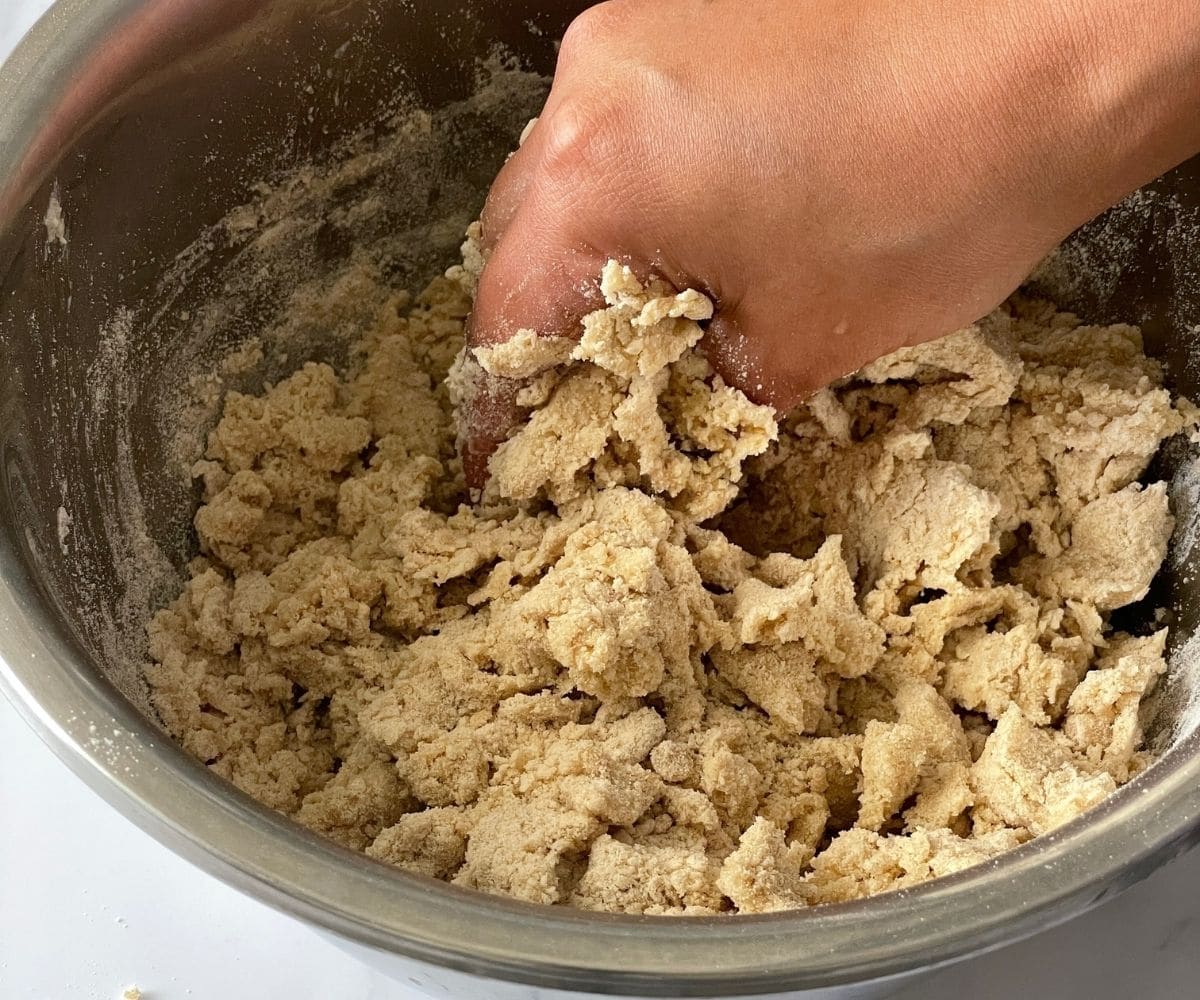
[0,0,1200,1000]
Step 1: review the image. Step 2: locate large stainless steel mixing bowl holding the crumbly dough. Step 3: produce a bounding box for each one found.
[0,0,1200,996]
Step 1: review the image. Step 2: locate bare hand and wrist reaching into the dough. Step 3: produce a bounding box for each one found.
[463,0,1200,486]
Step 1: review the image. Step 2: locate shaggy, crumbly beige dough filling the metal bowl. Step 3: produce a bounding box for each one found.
[148,231,1195,914]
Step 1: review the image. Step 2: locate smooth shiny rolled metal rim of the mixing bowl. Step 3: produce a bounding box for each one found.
[7,0,1200,996]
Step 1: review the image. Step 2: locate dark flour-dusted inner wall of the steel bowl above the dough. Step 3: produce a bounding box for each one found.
[0,0,1200,742]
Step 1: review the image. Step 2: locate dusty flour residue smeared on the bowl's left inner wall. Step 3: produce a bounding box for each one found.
[65,56,547,717]
